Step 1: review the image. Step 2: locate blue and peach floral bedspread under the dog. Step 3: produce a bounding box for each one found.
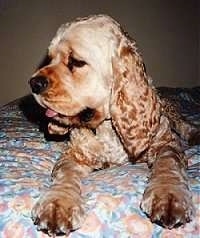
[0,88,200,238]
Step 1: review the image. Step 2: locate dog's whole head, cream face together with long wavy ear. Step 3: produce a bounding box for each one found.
[30,15,161,157]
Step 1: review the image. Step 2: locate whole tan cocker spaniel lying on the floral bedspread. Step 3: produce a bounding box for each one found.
[29,15,198,236]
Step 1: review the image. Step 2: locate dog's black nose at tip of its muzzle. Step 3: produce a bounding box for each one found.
[29,75,48,94]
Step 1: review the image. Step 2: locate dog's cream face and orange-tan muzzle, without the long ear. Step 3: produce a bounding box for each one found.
[30,16,119,131]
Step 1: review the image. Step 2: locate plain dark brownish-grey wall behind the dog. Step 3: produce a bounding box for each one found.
[0,0,200,105]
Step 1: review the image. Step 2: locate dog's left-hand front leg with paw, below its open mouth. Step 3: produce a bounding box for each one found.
[32,158,89,235]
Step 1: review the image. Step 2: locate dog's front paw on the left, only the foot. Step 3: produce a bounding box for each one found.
[32,192,84,236]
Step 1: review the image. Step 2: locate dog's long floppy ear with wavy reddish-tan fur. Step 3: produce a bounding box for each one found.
[111,36,160,159]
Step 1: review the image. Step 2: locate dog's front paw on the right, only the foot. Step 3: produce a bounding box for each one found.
[141,185,194,229]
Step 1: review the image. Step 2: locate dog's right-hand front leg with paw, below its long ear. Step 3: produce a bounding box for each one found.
[141,146,194,229]
